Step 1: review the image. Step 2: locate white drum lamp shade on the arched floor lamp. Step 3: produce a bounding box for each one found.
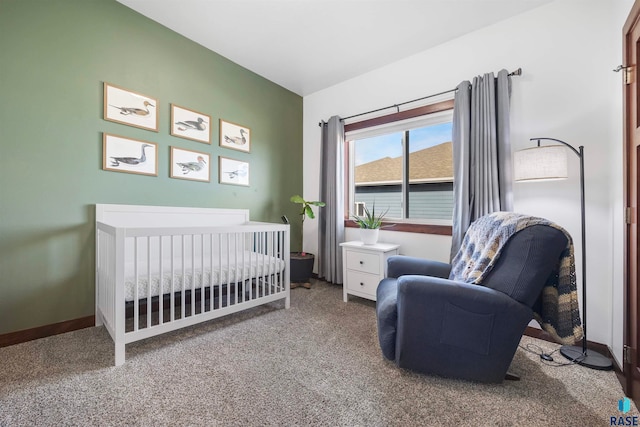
[513,145,568,181]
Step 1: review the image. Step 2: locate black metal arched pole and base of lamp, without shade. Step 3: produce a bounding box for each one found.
[530,138,613,370]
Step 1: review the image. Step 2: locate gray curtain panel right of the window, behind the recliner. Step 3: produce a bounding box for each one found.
[451,70,513,259]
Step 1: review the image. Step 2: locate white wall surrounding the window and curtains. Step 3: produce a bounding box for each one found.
[304,0,633,368]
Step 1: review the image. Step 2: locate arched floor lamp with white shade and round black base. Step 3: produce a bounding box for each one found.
[514,138,613,370]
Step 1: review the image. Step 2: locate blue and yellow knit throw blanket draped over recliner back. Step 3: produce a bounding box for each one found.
[449,212,582,345]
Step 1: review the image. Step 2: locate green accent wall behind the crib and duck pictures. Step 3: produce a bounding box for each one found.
[0,0,302,334]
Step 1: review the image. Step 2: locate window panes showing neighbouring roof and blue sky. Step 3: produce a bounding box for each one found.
[346,101,454,232]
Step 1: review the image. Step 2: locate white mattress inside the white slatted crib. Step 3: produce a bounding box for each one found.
[124,251,285,302]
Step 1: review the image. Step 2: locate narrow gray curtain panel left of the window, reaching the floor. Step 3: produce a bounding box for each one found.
[317,116,345,284]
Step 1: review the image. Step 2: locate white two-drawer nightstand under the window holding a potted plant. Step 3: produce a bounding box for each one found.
[340,242,400,302]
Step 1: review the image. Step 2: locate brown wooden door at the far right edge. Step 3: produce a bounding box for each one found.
[623,0,640,406]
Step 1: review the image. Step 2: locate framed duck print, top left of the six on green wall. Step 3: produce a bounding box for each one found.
[103,82,160,132]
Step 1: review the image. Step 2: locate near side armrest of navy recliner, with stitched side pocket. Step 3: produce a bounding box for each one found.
[395,276,533,382]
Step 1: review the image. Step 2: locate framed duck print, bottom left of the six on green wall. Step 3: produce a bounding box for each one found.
[102,133,158,176]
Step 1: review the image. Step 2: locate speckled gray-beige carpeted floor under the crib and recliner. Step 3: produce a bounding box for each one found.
[0,282,638,427]
